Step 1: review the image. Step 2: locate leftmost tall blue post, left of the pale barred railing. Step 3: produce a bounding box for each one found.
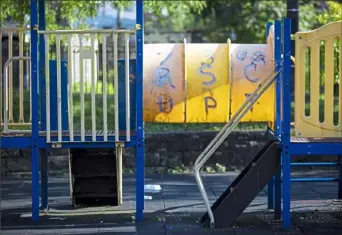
[30,0,39,221]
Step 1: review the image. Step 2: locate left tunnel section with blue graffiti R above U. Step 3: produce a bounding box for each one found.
[144,44,184,122]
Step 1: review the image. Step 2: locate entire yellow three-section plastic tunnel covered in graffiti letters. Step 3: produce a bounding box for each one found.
[144,41,274,123]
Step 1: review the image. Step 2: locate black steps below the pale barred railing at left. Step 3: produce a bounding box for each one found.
[70,148,118,206]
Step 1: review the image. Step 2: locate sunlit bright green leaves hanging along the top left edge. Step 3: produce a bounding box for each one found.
[0,0,205,30]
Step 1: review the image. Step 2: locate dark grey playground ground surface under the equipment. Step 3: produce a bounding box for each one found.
[0,171,342,235]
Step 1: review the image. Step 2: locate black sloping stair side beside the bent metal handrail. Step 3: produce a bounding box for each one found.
[200,140,280,228]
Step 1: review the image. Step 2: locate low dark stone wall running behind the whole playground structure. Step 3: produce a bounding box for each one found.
[1,131,336,173]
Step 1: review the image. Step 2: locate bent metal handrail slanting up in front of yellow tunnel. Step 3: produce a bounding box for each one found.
[194,68,280,228]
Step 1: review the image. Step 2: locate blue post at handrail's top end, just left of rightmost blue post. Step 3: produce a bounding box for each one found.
[274,20,282,219]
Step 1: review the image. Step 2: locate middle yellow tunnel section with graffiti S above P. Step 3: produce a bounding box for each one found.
[185,44,229,122]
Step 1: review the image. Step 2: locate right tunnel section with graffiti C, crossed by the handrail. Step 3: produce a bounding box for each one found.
[230,44,275,122]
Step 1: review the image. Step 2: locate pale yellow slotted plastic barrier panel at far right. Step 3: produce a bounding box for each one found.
[295,21,342,137]
